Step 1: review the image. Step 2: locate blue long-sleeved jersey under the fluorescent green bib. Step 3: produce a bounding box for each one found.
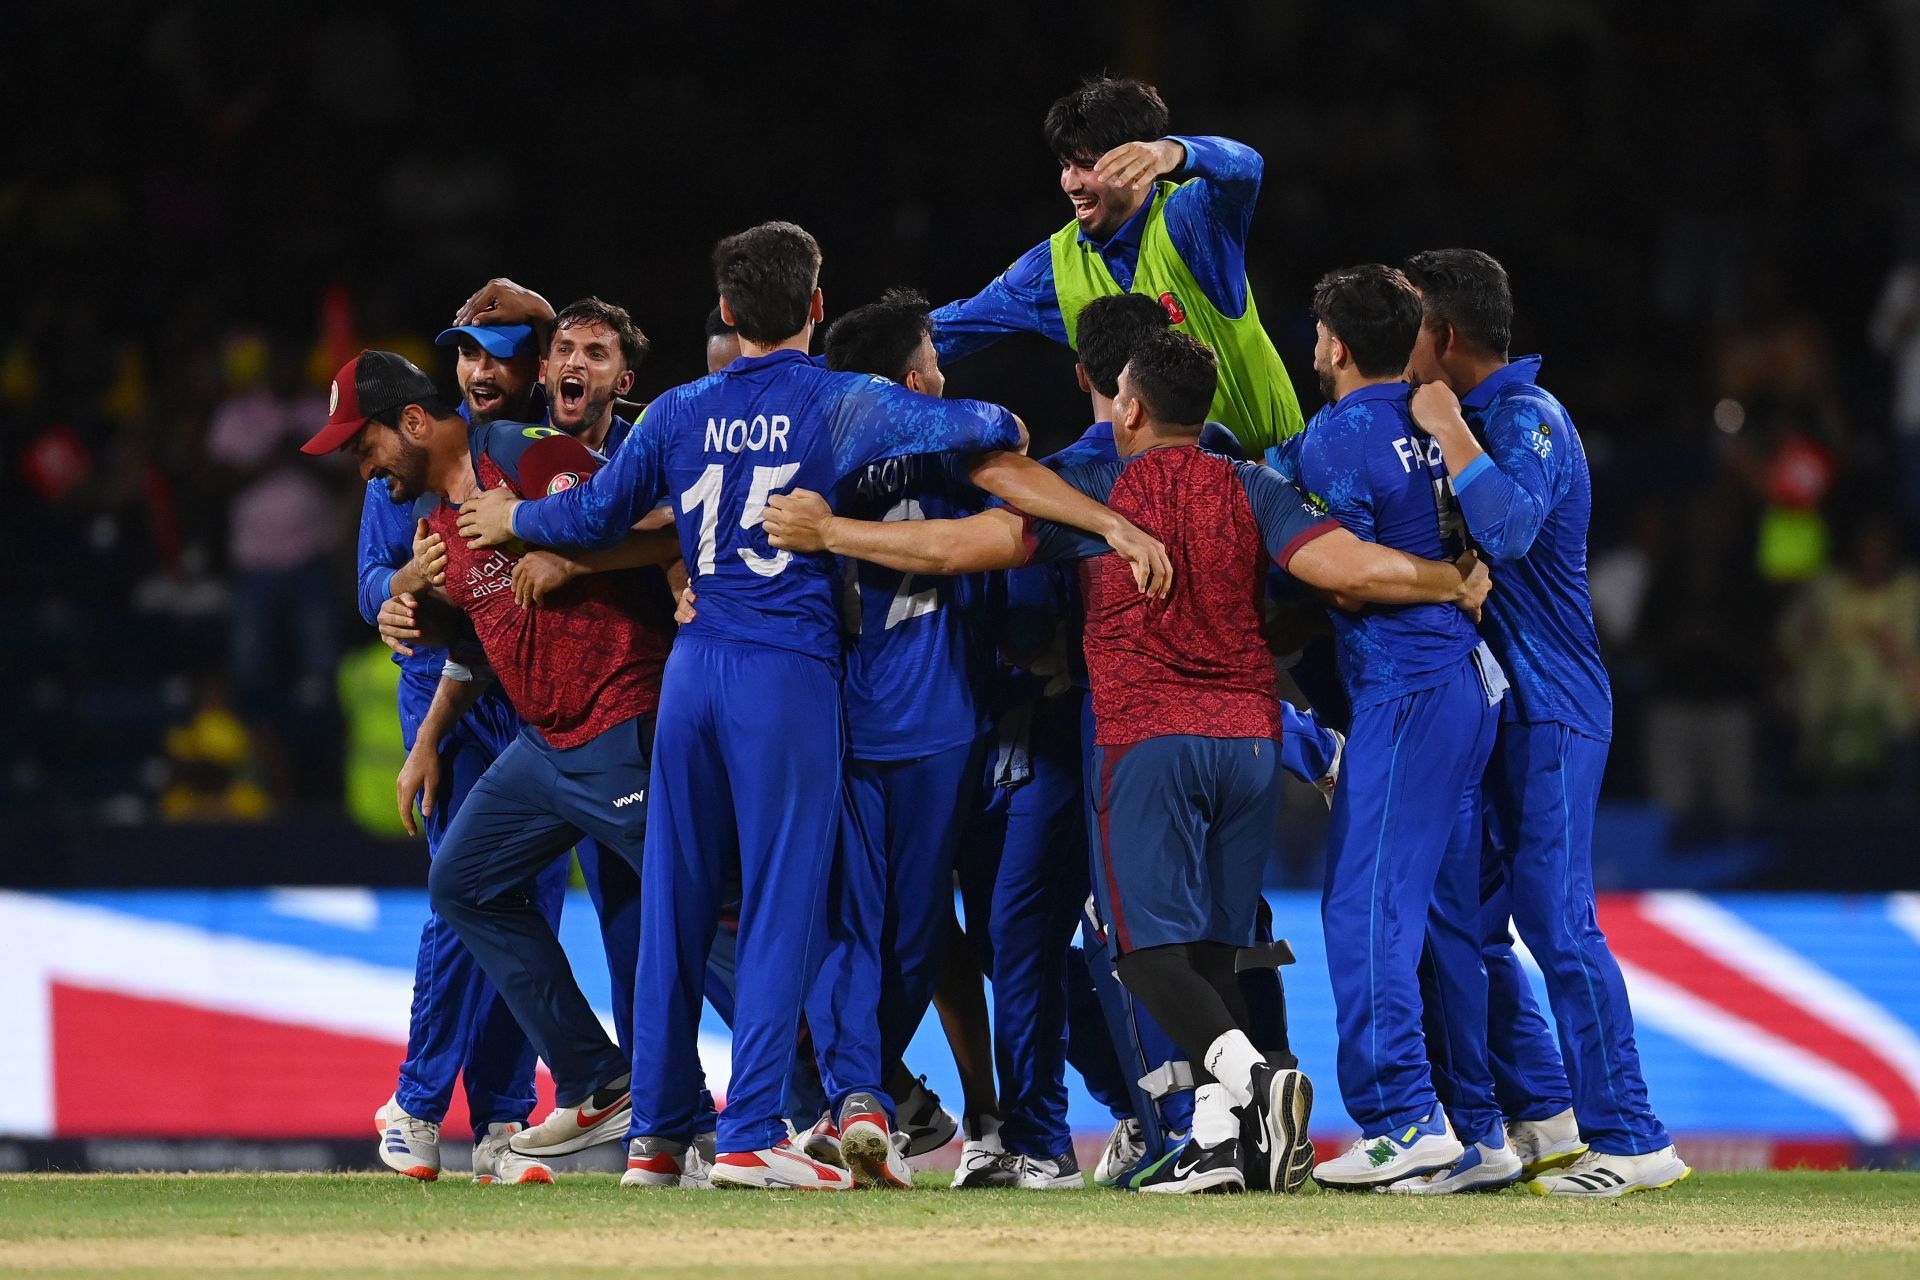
[933,134,1265,361]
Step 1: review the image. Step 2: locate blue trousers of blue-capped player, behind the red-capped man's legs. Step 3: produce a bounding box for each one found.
[394,687,566,1132]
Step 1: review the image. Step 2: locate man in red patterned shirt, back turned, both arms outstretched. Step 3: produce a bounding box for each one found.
[766,334,1486,1192]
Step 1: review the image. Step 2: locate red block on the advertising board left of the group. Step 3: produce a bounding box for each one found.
[52,983,553,1144]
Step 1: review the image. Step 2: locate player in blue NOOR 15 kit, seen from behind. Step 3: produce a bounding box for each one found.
[461,223,1167,1190]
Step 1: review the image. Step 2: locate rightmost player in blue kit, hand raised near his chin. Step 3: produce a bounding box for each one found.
[1405,249,1692,1196]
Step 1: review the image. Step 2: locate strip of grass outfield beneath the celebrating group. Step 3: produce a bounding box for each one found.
[0,1173,1920,1280]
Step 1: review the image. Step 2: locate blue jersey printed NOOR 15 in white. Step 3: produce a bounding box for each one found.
[513,351,1020,664]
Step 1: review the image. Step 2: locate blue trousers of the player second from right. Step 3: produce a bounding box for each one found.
[1321,658,1500,1142]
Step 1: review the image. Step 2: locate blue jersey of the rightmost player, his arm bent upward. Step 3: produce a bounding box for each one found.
[1453,355,1613,741]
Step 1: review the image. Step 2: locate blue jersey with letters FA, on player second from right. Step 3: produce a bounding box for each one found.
[1296,382,1480,712]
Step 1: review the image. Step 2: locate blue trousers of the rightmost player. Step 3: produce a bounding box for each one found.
[1480,723,1672,1155]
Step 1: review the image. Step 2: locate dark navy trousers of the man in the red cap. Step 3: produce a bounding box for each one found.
[426,716,645,1107]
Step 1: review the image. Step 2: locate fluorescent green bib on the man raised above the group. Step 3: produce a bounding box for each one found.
[1052,178,1304,459]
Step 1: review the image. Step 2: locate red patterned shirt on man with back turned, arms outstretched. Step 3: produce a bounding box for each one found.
[1025,445,1340,747]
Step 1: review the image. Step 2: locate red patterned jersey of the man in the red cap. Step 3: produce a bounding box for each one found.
[417,422,674,750]
